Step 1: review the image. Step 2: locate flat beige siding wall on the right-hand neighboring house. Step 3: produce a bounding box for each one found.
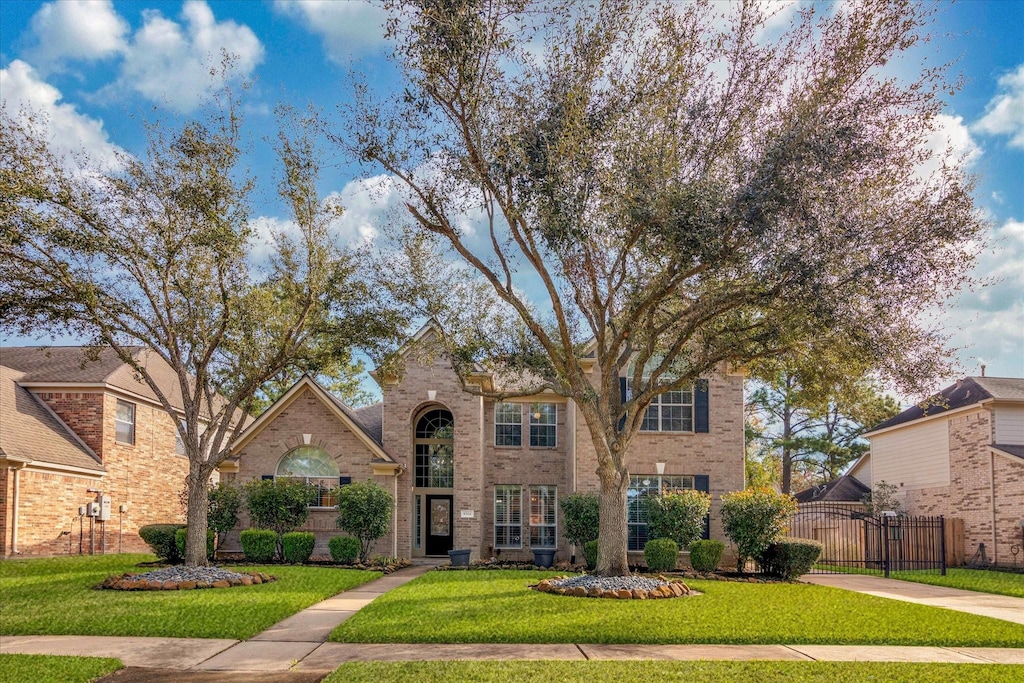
[865,419,950,494]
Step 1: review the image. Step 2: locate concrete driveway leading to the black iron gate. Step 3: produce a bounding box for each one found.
[801,573,1024,624]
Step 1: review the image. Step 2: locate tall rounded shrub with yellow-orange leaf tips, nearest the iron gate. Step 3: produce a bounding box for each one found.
[722,486,797,571]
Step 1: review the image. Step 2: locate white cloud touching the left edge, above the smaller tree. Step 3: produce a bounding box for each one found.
[0,59,120,170]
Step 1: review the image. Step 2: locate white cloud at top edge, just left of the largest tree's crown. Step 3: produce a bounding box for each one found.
[273,0,387,63]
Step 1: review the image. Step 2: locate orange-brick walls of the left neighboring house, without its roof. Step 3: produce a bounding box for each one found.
[0,390,188,557]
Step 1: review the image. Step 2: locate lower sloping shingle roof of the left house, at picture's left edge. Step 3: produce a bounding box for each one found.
[0,366,106,474]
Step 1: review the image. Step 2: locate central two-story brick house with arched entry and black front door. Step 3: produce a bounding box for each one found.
[222,325,744,560]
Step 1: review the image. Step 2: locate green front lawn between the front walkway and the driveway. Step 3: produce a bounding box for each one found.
[331,571,1024,647]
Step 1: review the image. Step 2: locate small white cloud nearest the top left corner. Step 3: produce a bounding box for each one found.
[25,0,128,73]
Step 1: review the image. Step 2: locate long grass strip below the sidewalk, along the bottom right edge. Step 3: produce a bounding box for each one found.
[324,661,1024,683]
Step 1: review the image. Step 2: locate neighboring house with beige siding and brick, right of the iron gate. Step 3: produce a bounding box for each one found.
[857,377,1024,565]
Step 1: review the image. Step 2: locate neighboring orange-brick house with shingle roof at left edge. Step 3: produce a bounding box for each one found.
[0,346,201,557]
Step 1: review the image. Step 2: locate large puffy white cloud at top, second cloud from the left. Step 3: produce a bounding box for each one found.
[113,0,263,113]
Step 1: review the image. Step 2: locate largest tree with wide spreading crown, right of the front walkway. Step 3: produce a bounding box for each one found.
[352,0,983,574]
